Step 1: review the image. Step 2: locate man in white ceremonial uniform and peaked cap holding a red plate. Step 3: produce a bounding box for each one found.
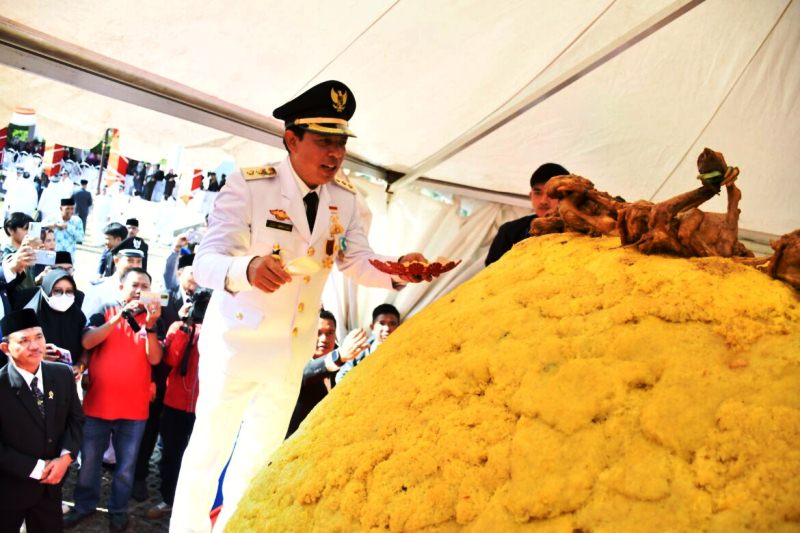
[170,81,425,533]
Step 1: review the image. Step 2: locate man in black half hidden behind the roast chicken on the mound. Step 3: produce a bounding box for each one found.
[485,163,569,266]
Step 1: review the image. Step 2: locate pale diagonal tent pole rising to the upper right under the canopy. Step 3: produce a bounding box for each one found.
[389,0,704,193]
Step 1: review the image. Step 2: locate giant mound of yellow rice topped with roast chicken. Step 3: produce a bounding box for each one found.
[229,235,800,532]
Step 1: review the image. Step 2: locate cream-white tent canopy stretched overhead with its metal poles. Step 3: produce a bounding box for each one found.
[0,0,800,328]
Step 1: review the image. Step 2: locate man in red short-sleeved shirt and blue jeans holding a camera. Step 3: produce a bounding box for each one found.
[64,268,162,531]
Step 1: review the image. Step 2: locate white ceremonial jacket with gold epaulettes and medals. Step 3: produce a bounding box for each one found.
[193,158,392,382]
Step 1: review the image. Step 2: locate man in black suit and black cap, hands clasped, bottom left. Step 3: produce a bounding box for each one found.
[0,309,83,533]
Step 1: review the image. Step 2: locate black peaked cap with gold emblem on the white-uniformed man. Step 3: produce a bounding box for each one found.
[272,80,356,137]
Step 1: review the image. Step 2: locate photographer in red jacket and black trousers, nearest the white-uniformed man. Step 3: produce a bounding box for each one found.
[145,289,211,520]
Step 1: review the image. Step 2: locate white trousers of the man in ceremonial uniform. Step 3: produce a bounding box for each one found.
[169,368,300,533]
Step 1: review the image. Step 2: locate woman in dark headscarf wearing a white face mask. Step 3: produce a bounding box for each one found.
[24,268,86,365]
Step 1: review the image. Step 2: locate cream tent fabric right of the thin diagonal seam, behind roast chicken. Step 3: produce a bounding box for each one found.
[655,1,800,235]
